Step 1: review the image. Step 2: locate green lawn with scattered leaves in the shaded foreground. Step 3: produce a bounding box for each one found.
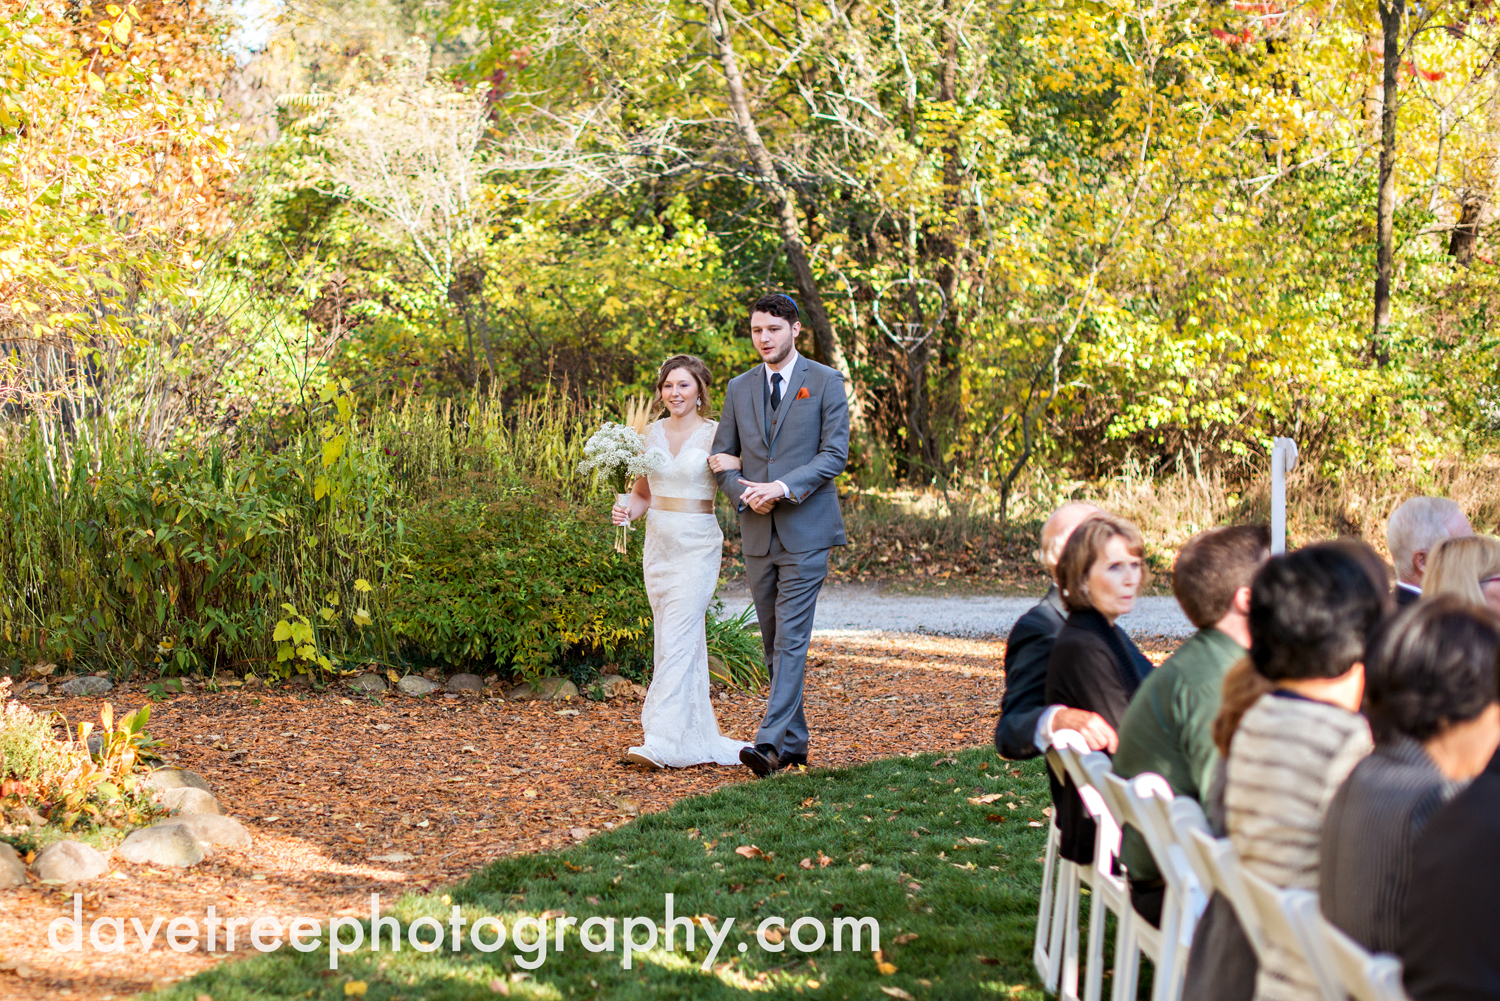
[150,749,1049,1001]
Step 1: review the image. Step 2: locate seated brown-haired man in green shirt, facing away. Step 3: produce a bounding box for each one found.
[1113,525,1271,926]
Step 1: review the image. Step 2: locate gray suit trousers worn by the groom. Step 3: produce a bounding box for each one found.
[746,531,828,755]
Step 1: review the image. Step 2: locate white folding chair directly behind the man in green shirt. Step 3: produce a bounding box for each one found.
[1103,773,1208,1001]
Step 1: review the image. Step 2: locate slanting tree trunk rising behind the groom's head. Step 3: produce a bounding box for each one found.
[704,0,854,387]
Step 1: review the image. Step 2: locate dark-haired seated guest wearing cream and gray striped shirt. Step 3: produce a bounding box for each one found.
[1224,545,1382,1001]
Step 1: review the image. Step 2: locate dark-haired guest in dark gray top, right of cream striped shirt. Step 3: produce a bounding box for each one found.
[1319,594,1500,953]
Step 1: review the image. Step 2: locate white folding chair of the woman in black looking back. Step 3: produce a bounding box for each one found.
[1055,731,1134,1001]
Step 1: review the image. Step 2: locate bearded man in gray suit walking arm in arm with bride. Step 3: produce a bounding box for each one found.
[710,294,849,776]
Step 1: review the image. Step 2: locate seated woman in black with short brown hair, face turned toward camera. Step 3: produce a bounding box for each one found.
[1047,515,1151,863]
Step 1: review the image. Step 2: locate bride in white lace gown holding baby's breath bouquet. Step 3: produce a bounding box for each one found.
[612,354,746,768]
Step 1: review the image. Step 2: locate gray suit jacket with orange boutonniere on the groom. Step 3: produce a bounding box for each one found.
[714,356,849,557]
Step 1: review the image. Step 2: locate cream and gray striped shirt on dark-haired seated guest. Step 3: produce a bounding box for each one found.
[1224,690,1373,1001]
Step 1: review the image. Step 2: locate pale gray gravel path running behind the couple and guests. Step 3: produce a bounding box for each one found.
[720,584,1194,638]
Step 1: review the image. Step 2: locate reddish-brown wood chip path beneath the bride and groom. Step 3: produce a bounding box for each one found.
[0,635,1175,1001]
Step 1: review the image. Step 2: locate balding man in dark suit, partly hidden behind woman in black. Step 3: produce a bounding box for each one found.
[995,501,1115,761]
